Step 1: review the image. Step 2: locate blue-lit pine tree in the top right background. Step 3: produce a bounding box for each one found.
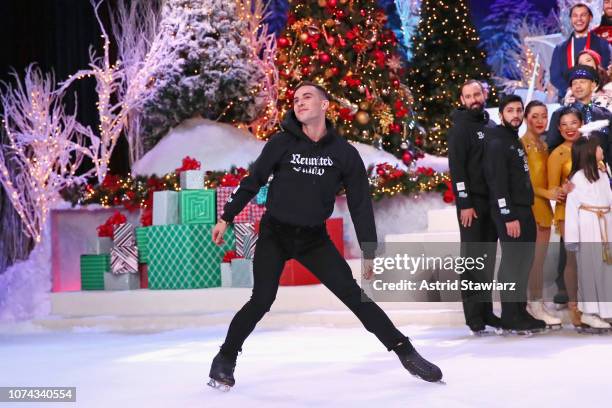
[480,0,545,80]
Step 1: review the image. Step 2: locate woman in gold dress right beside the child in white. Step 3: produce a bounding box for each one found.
[547,107,582,327]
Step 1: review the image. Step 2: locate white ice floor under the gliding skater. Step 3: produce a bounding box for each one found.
[0,326,612,408]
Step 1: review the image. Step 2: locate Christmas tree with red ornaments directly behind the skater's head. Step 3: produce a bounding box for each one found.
[277,0,422,164]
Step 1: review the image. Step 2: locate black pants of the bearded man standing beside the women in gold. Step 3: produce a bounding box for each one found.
[492,206,537,310]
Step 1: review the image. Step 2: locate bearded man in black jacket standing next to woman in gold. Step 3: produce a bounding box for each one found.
[484,95,546,333]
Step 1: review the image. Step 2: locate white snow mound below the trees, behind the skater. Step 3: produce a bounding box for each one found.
[132,118,448,176]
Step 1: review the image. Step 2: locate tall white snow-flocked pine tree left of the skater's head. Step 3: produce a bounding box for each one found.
[141,0,268,151]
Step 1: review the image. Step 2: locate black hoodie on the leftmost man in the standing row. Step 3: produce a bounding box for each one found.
[447,108,494,210]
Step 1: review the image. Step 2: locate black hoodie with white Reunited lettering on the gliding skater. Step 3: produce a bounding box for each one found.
[221,110,376,258]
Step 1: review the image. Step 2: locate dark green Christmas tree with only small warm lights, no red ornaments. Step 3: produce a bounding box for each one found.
[407,0,497,155]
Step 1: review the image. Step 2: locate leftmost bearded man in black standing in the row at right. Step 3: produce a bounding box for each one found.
[447,79,501,335]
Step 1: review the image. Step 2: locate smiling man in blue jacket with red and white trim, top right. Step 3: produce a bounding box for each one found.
[549,3,610,99]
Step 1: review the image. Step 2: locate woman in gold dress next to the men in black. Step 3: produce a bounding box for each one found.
[521,101,565,327]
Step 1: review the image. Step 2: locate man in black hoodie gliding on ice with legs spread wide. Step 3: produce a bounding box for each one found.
[209,83,442,388]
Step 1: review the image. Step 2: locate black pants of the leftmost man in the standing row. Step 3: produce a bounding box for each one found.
[457,196,497,328]
